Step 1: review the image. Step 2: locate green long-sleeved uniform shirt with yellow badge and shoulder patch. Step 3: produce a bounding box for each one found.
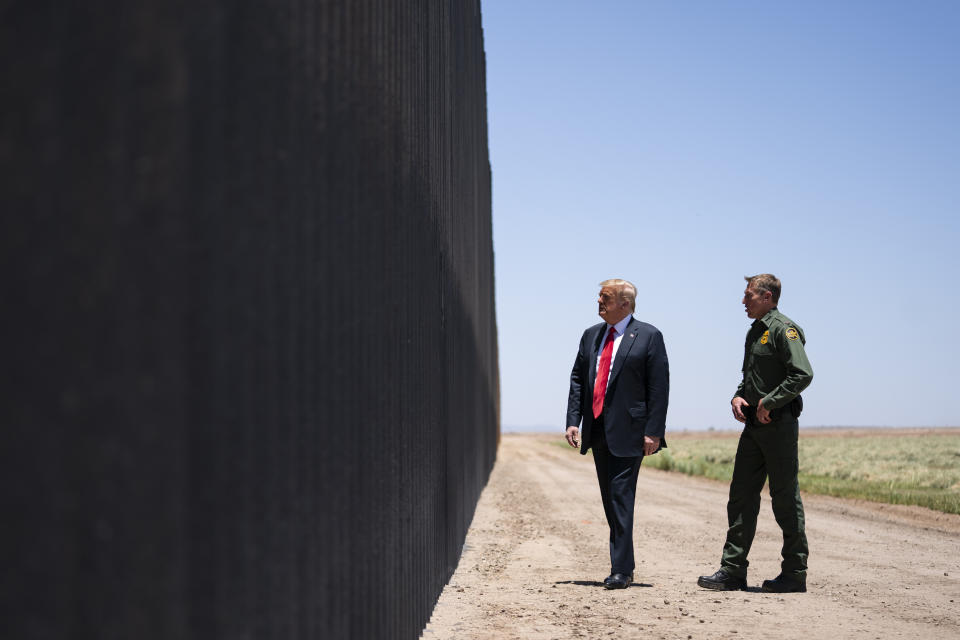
[734,307,813,410]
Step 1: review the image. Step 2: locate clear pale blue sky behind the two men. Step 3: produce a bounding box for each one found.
[482,0,960,431]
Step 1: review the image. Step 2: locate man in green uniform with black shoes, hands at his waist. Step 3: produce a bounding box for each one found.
[697,273,813,593]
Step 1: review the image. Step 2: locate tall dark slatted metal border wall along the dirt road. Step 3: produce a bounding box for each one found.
[0,0,499,640]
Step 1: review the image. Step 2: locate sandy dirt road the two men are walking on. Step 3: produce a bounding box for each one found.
[423,434,960,640]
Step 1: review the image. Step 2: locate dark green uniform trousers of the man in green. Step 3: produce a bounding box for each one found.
[720,412,809,578]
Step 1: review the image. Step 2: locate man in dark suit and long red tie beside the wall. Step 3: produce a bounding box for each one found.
[567,280,670,589]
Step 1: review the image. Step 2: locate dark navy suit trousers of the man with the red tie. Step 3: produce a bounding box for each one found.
[590,424,643,574]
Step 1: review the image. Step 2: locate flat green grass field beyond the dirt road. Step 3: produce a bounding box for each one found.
[643,429,960,514]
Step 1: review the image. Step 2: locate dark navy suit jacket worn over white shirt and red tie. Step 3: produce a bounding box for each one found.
[567,318,670,457]
